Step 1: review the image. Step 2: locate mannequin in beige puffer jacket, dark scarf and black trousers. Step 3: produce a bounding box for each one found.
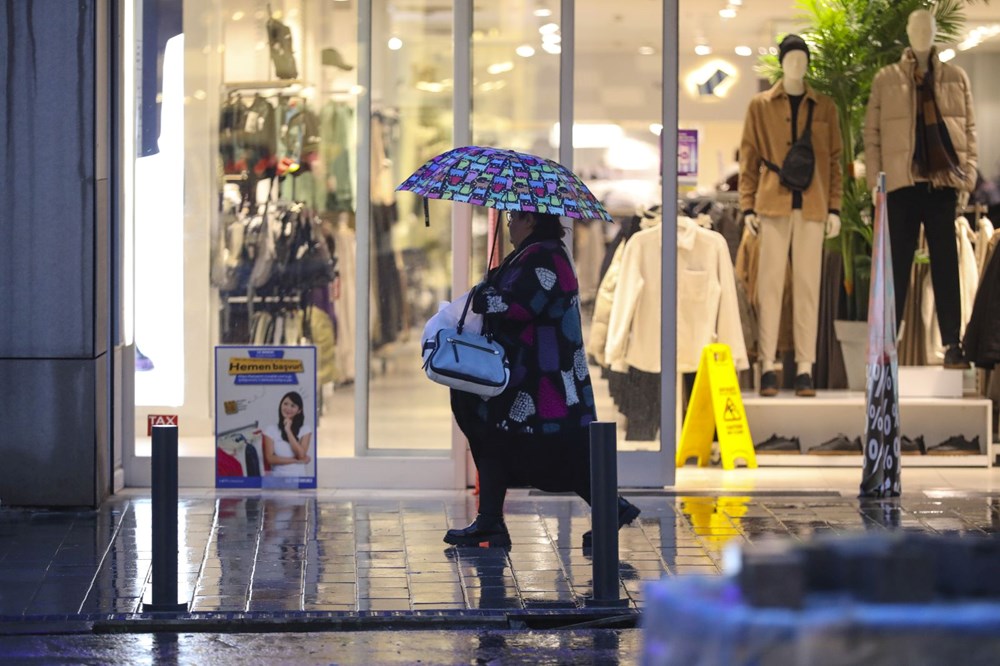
[864,9,978,369]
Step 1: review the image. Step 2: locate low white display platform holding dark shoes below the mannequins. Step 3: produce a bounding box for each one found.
[743,390,996,467]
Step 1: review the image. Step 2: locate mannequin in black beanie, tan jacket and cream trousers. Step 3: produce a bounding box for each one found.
[739,35,842,397]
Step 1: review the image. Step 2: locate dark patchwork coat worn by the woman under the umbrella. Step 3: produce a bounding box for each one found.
[472,237,597,435]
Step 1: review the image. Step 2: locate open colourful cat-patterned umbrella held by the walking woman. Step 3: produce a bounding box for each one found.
[396,146,611,222]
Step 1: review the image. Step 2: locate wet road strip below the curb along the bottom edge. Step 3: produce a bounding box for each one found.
[3,629,642,666]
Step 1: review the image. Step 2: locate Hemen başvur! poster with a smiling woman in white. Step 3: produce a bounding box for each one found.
[215,345,316,488]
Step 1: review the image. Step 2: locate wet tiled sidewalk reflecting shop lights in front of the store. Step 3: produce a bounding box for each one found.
[0,492,1000,616]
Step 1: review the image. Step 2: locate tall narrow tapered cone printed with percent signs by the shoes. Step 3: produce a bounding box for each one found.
[861,173,900,498]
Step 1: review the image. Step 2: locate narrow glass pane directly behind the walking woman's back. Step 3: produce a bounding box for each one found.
[580,0,672,451]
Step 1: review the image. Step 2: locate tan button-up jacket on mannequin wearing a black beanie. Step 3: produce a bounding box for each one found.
[739,81,843,223]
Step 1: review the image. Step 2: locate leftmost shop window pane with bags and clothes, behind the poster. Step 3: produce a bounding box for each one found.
[134,0,359,457]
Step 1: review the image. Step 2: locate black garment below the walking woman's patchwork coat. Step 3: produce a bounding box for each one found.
[451,390,590,516]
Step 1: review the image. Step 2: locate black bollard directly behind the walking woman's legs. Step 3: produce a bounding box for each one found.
[586,421,628,607]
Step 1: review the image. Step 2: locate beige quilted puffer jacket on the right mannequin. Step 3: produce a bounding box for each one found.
[864,48,979,192]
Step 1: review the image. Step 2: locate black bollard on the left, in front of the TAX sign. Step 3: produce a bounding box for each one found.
[142,425,188,613]
